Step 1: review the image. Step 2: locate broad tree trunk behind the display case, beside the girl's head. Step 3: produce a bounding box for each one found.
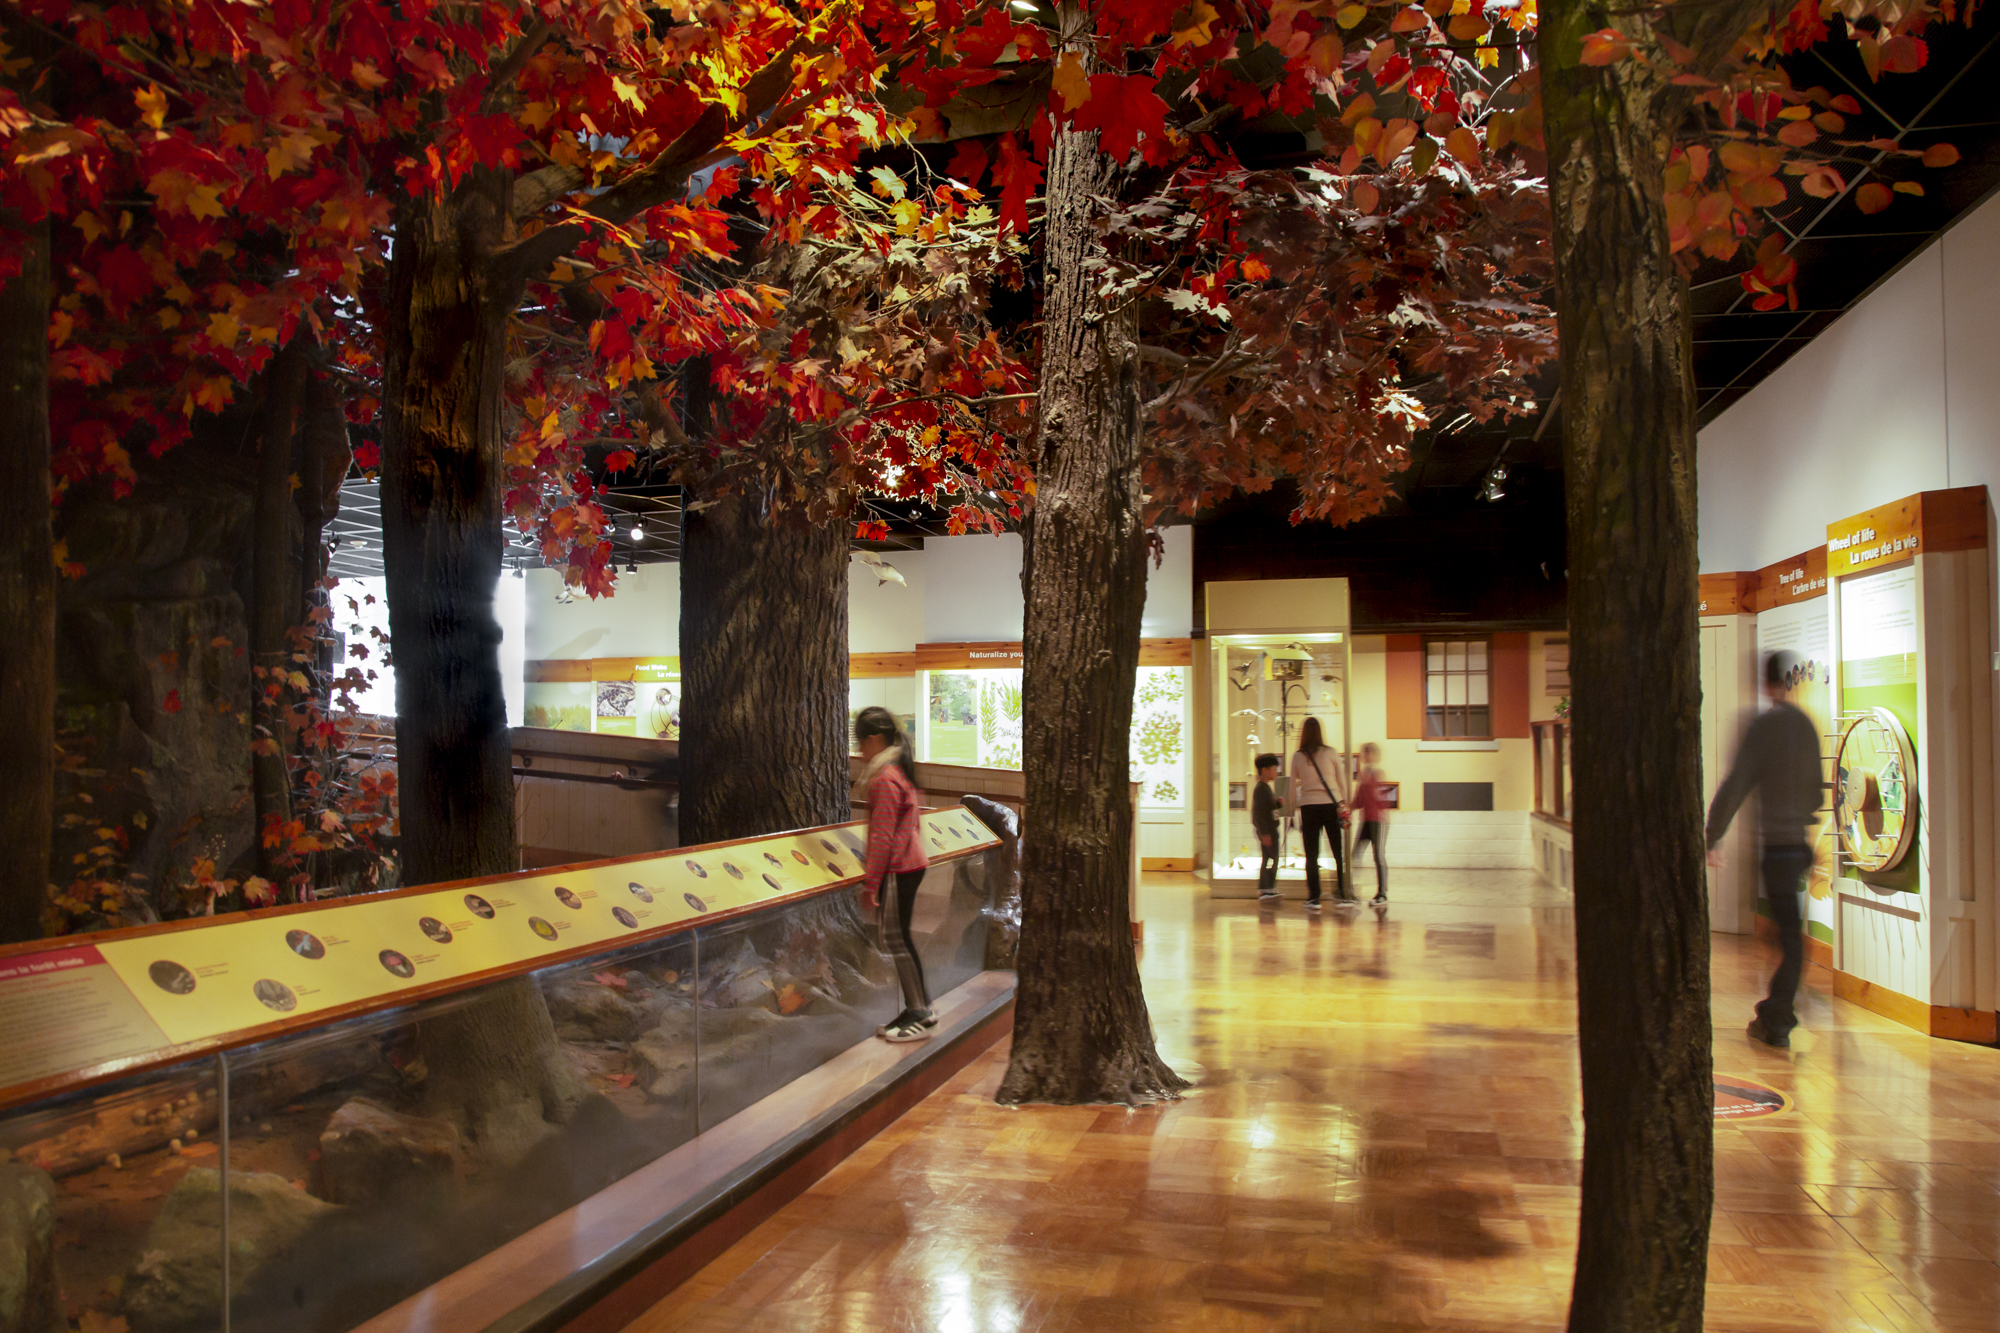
[680,482,850,845]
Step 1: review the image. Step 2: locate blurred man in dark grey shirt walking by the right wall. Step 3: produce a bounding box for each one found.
[1708,652,1826,1047]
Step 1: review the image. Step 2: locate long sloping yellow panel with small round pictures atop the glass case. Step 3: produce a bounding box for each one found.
[0,809,998,1087]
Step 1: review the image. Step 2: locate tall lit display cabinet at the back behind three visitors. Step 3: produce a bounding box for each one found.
[1206,578,1354,897]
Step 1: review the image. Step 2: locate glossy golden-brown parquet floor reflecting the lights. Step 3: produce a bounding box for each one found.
[630,869,2000,1333]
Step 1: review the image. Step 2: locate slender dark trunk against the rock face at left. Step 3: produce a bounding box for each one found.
[250,340,306,872]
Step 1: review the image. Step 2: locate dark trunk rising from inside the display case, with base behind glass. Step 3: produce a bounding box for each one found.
[382,172,586,1159]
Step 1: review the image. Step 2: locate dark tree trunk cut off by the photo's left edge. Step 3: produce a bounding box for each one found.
[0,220,56,943]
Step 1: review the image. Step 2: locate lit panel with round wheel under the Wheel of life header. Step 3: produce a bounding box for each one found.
[1834,562,1920,880]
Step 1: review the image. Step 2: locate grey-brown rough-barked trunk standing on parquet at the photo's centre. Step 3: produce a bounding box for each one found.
[1000,91,1186,1103]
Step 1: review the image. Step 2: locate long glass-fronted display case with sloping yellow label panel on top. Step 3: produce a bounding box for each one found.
[0,809,998,1333]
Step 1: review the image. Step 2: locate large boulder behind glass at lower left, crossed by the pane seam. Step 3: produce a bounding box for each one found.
[124,1167,336,1333]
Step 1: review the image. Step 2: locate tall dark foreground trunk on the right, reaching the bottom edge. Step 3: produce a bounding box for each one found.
[1540,0,1760,1333]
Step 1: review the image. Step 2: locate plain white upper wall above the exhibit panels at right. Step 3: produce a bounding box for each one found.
[1698,183,2000,572]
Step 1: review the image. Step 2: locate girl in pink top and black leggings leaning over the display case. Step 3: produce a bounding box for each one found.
[854,707,938,1041]
